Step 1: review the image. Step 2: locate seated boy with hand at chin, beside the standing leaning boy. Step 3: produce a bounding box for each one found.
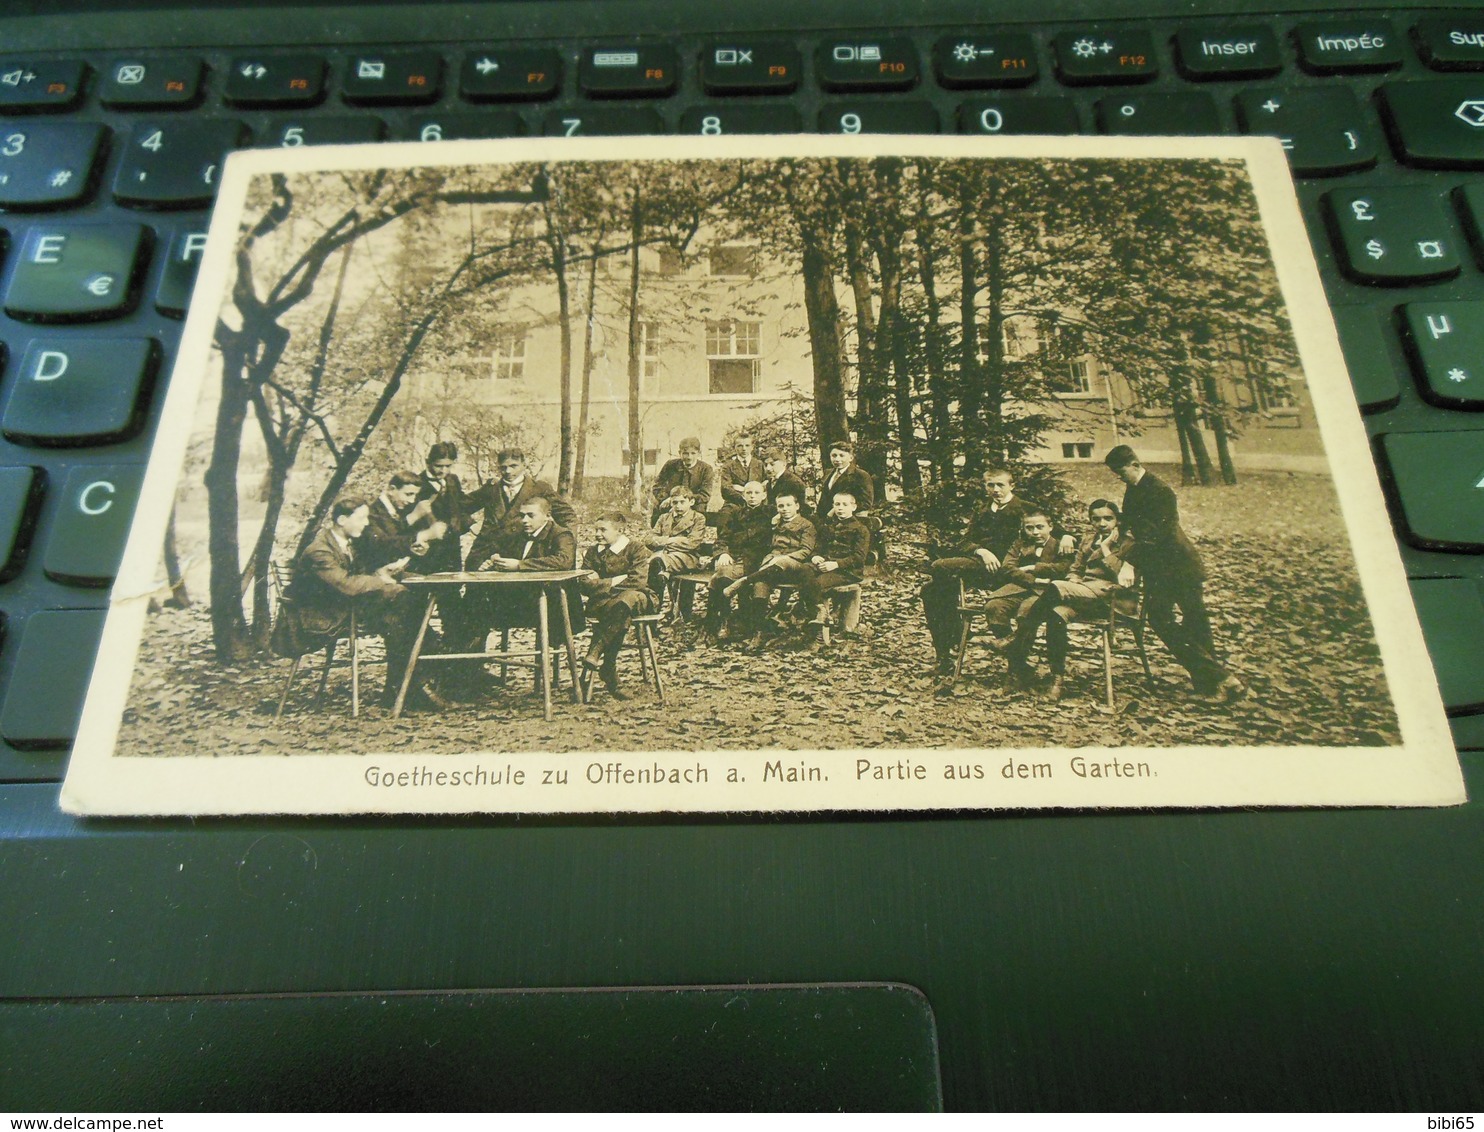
[1006,498,1128,700]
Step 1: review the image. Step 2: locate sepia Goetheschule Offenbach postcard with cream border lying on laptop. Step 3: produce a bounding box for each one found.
[62,136,1465,815]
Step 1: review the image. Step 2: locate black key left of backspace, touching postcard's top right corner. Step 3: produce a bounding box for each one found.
[1236,86,1377,177]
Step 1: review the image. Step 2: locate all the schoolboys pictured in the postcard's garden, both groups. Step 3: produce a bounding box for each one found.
[275,438,1245,706]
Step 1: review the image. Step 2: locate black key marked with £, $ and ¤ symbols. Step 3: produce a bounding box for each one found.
[1325,188,1460,285]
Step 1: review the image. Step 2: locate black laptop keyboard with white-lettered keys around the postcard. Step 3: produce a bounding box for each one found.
[0,10,1484,780]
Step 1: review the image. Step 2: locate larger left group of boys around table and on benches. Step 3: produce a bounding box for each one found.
[275,438,874,708]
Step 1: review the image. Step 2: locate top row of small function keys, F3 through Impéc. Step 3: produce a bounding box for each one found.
[0,13,1484,113]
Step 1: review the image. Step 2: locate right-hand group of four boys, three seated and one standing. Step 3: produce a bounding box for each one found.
[922,444,1247,702]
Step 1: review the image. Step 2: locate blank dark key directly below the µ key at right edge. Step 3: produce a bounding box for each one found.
[1382,432,1484,554]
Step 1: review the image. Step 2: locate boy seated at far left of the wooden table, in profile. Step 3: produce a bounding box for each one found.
[272,496,444,706]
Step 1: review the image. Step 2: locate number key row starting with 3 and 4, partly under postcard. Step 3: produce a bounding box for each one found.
[0,79,1484,211]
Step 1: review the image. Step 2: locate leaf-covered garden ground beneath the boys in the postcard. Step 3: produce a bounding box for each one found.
[120,469,1398,755]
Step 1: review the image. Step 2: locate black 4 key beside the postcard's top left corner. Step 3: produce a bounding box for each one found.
[113,119,242,208]
